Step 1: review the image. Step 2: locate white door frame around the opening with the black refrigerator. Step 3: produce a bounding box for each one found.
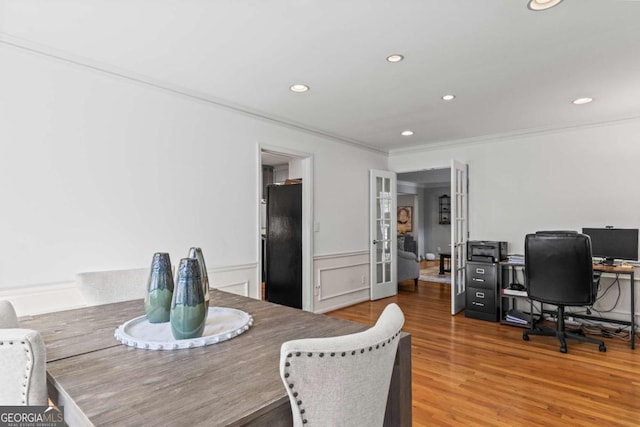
[251,142,314,312]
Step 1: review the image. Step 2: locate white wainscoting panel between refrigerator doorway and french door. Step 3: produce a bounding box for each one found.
[313,251,369,313]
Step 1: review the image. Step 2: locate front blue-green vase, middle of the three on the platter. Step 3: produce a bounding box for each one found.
[170,258,207,340]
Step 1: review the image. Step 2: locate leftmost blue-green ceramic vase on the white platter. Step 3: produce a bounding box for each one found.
[144,252,173,323]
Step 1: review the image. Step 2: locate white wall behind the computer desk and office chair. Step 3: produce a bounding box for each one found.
[389,119,640,320]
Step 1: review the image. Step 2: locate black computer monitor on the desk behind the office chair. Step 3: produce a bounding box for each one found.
[582,228,638,265]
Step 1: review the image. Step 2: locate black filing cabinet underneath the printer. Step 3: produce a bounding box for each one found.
[464,261,500,322]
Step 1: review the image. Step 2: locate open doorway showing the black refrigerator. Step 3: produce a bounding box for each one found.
[258,147,313,311]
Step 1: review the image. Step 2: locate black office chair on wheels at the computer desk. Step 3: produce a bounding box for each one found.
[522,231,607,353]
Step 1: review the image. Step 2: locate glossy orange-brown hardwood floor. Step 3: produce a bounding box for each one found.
[328,281,640,427]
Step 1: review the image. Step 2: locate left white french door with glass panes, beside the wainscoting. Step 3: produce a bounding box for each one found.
[369,169,398,300]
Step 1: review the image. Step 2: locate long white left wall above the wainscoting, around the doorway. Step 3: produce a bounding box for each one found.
[0,44,387,310]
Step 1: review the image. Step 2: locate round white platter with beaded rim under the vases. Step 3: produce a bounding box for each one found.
[114,307,253,350]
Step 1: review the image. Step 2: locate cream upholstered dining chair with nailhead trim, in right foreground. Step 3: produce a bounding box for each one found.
[280,303,404,427]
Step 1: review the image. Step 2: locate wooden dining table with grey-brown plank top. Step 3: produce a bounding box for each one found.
[20,290,411,427]
